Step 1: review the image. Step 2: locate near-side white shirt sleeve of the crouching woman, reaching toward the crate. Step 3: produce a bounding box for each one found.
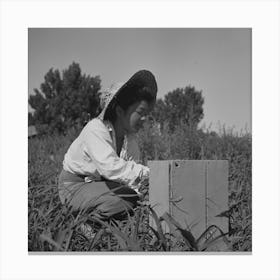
[84,121,149,188]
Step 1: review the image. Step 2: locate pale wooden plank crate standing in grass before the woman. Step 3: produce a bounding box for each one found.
[148,160,228,238]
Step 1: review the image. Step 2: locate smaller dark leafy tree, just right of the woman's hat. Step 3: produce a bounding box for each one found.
[152,86,204,131]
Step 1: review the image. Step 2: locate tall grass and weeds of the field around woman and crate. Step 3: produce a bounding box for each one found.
[28,121,252,252]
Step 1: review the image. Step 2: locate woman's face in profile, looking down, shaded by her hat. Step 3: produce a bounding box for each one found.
[121,100,152,134]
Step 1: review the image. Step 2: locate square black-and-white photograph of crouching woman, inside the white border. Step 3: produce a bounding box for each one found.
[28,28,252,254]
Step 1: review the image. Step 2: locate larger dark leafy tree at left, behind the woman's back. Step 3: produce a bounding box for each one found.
[29,62,101,132]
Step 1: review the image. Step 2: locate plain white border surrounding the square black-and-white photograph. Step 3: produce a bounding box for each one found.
[0,0,280,280]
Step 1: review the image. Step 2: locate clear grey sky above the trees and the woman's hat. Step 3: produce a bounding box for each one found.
[28,28,252,132]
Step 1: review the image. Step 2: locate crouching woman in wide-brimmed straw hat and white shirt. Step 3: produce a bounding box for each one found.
[58,70,157,219]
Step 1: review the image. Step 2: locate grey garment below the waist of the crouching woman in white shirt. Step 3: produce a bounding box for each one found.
[58,169,140,220]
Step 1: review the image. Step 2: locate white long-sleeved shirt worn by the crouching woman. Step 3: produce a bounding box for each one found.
[63,118,149,189]
